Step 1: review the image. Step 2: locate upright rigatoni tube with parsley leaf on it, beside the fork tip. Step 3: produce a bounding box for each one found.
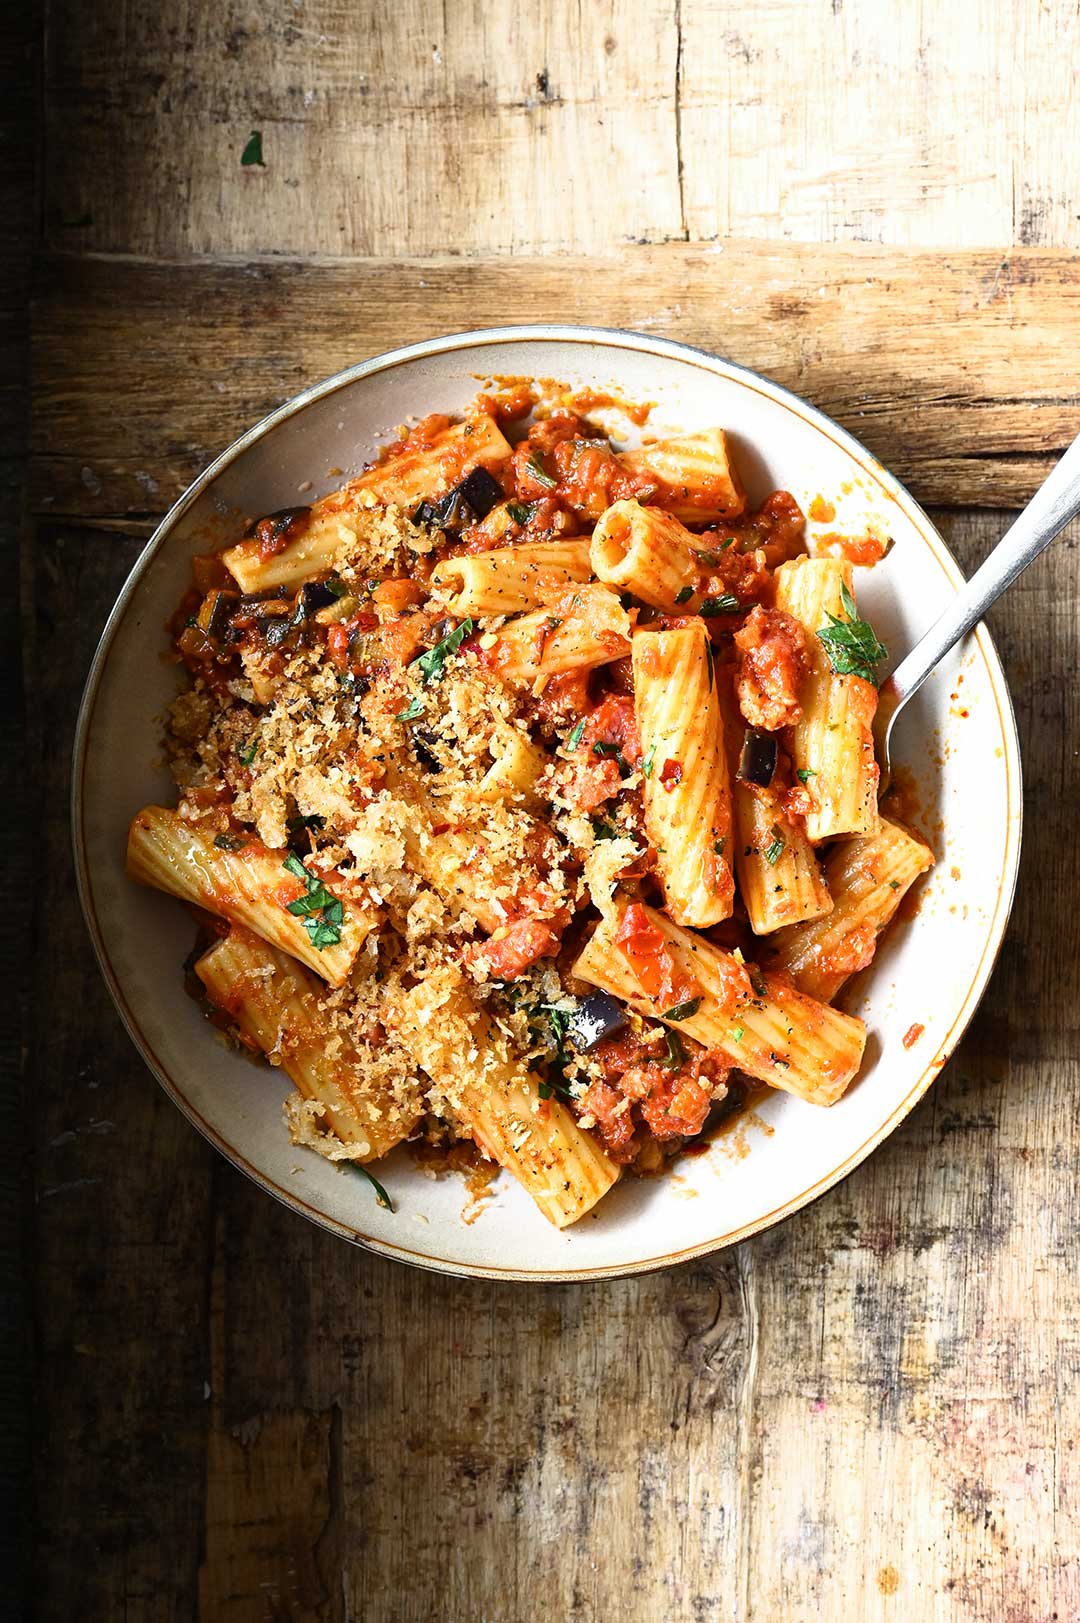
[776,558,877,844]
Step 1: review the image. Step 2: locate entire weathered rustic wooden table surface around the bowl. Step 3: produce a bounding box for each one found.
[21,0,1080,1623]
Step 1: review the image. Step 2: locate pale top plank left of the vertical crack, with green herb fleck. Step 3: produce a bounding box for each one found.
[45,0,682,255]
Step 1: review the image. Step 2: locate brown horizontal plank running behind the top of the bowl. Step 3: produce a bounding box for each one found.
[32,243,1080,519]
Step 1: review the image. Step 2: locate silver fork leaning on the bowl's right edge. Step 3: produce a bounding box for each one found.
[874,437,1080,794]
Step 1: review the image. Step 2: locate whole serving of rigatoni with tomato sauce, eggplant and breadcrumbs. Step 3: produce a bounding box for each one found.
[128,383,932,1229]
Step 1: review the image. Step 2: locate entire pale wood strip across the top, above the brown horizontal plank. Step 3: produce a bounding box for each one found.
[44,0,1080,256]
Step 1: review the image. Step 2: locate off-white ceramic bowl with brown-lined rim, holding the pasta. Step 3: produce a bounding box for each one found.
[73,326,1020,1279]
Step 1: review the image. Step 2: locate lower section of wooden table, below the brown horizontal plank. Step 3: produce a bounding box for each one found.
[29,513,1080,1623]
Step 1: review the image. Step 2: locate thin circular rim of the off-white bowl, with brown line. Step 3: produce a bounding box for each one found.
[71,321,1023,1284]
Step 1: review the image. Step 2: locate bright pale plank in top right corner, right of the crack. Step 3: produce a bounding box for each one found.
[679,0,1080,248]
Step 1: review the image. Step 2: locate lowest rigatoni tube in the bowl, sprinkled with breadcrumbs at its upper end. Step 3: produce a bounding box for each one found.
[391,972,619,1229]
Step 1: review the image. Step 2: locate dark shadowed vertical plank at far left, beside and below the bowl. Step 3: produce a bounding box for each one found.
[23,534,214,1623]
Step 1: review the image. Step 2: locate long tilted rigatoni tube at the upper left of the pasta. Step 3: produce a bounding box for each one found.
[221,412,510,592]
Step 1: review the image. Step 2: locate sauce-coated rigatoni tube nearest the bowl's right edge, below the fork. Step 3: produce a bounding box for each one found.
[770,816,934,1003]
